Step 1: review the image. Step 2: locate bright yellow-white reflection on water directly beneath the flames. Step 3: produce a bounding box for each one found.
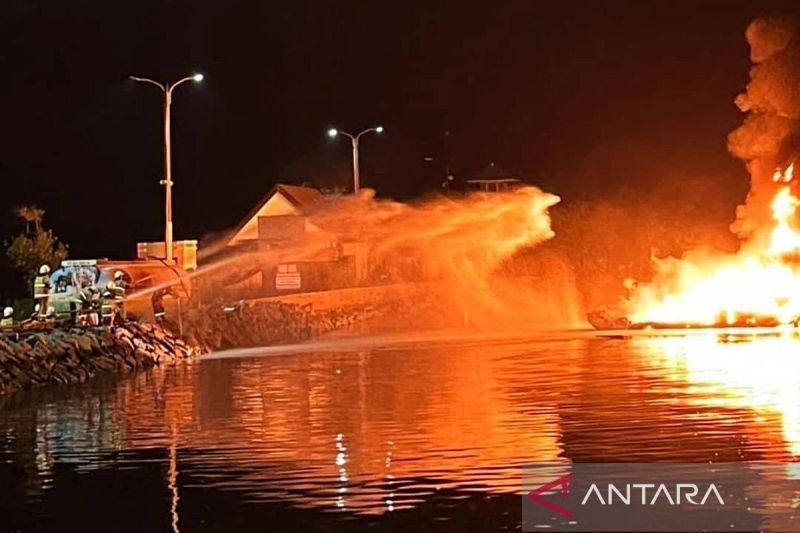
[644,330,800,456]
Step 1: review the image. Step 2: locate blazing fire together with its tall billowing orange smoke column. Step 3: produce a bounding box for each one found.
[616,18,800,327]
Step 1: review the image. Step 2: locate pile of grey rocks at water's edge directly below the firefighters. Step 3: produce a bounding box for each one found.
[0,323,195,394]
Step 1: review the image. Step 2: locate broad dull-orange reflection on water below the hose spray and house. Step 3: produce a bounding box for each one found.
[120,338,576,513]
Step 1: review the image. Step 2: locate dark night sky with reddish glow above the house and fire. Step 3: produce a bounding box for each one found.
[0,0,798,257]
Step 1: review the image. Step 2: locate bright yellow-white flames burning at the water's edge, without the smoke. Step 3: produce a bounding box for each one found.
[629,164,800,326]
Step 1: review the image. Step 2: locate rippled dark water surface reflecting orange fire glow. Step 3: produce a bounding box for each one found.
[0,333,800,531]
